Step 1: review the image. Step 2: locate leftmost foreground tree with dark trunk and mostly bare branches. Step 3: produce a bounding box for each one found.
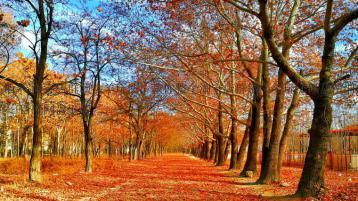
[0,0,54,182]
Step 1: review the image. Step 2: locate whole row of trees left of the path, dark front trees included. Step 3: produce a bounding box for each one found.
[0,0,190,181]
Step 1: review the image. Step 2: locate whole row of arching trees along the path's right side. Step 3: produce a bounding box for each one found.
[137,0,358,197]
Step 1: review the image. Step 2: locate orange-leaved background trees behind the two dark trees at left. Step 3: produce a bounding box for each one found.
[0,54,187,159]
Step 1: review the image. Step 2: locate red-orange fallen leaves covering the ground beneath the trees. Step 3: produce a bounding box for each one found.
[0,154,358,201]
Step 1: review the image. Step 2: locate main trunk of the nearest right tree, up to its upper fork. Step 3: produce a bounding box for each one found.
[296,32,337,197]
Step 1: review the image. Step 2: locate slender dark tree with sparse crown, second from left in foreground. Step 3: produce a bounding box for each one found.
[53,5,119,172]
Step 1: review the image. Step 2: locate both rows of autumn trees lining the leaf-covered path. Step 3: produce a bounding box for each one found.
[0,0,358,199]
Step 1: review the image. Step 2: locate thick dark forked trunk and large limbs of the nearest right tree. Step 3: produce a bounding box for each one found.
[259,0,358,197]
